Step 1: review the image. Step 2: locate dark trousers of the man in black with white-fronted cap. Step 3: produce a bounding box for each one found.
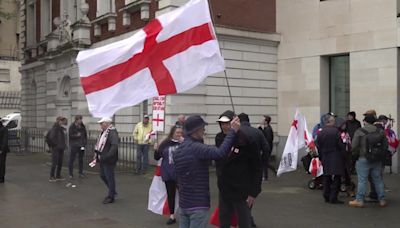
[219,194,251,228]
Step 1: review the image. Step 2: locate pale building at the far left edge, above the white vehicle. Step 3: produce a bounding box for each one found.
[0,0,21,117]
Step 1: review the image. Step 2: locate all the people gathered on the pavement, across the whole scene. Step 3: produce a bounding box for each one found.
[0,110,398,228]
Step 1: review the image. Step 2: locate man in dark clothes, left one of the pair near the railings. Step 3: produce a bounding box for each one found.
[46,116,68,182]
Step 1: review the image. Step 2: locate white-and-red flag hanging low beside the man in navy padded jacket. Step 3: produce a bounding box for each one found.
[147,159,179,215]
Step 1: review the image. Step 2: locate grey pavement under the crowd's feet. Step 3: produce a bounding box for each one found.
[0,153,400,228]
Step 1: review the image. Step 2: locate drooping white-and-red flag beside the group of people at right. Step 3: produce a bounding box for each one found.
[277,109,316,176]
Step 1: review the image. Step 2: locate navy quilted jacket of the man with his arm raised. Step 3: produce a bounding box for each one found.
[174,130,236,210]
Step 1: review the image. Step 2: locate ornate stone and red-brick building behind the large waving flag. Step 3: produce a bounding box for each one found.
[20,0,280,146]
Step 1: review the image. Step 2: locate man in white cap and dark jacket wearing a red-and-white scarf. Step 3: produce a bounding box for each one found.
[95,117,119,204]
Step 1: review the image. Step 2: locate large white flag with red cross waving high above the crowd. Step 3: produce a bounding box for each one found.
[76,0,225,117]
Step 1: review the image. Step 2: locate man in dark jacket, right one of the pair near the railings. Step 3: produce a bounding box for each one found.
[68,115,87,178]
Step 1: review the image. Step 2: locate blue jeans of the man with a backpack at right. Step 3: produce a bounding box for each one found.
[356,157,385,201]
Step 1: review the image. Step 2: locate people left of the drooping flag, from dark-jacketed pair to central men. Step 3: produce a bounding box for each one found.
[39,110,275,227]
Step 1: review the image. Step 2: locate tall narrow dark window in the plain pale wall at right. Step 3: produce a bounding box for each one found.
[329,55,350,117]
